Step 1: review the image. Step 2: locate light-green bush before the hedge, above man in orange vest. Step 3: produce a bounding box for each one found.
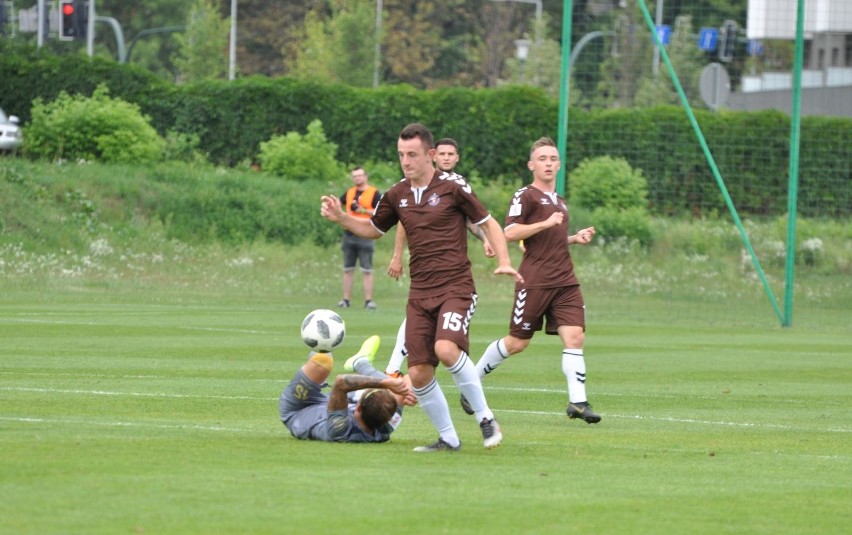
[260,119,346,182]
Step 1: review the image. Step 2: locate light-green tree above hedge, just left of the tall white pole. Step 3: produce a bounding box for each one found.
[174,0,230,82]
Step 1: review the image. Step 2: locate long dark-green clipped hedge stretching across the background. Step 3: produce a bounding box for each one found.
[0,41,852,217]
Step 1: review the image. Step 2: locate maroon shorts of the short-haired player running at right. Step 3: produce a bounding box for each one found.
[509,285,586,340]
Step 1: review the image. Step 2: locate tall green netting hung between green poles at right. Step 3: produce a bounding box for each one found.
[559,0,852,326]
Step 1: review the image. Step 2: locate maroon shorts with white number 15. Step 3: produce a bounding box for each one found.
[405,293,477,367]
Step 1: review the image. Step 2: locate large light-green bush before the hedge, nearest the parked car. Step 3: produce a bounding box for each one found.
[24,86,165,163]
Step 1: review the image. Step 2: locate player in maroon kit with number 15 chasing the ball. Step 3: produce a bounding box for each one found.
[320,123,523,452]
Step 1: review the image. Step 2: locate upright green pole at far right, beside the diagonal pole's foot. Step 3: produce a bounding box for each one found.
[781,0,805,327]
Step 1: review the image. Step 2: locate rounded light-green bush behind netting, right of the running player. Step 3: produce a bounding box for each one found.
[569,156,653,246]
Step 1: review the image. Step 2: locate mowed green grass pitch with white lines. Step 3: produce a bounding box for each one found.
[0,267,852,534]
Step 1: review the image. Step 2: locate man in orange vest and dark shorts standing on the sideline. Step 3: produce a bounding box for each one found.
[337,167,382,310]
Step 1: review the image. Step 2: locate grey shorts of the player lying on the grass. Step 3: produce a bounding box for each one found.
[278,369,328,440]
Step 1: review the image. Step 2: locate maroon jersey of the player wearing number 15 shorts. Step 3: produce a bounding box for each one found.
[371,171,491,298]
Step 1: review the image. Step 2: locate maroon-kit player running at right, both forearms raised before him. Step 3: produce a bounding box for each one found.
[461,137,601,424]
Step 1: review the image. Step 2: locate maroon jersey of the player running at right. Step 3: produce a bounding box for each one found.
[504,186,579,288]
